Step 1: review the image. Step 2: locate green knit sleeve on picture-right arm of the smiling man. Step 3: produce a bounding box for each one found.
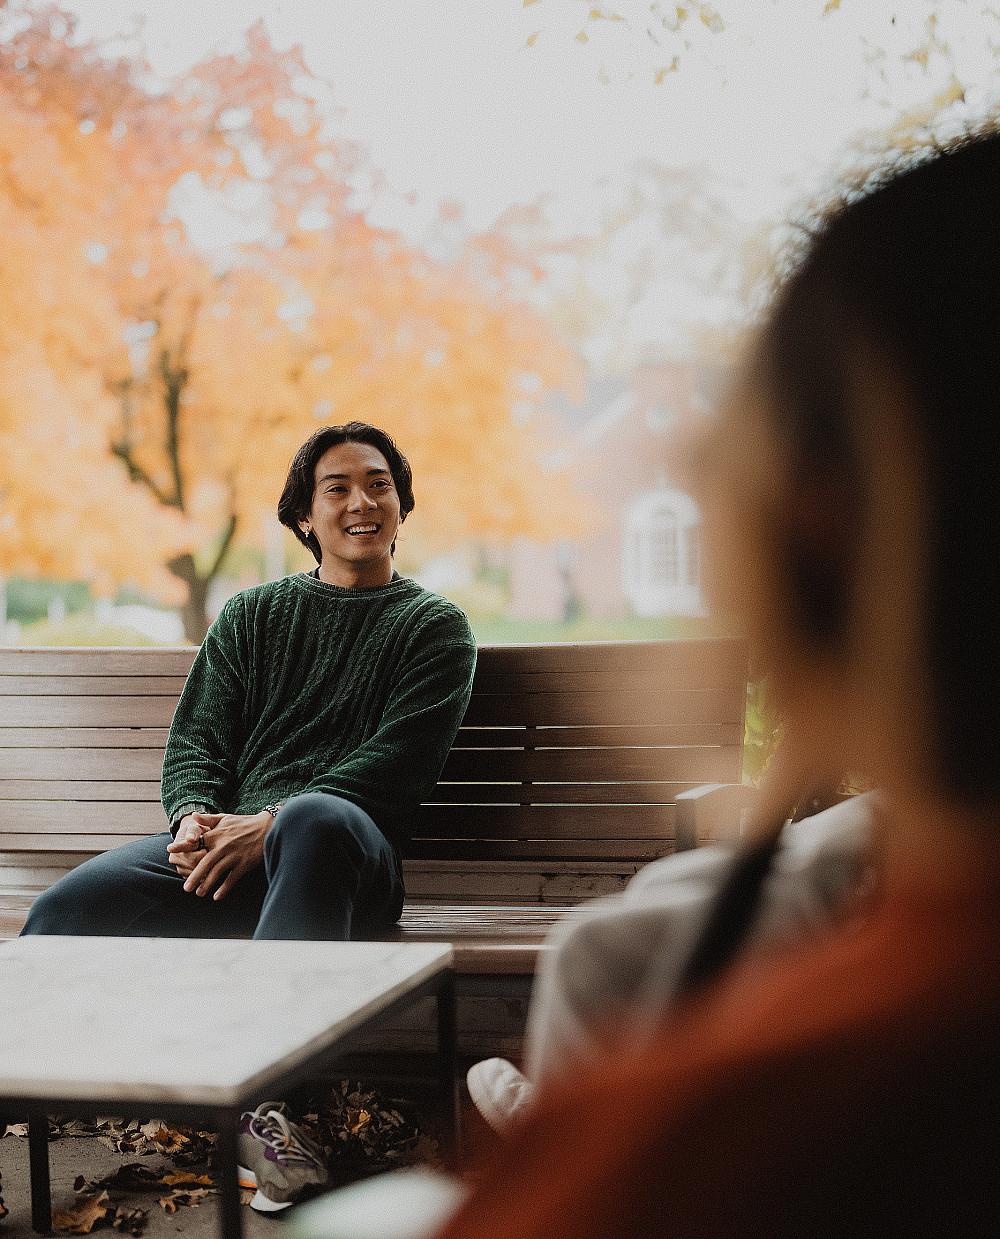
[302,610,476,843]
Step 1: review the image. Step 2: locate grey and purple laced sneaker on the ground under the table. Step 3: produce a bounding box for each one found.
[237,1101,328,1213]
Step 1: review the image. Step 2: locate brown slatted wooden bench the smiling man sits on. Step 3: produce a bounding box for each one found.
[0,639,747,1053]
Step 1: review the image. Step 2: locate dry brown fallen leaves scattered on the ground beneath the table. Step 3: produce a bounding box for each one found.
[0,1080,440,1237]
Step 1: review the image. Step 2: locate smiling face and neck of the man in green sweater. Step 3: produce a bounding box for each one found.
[299,442,399,589]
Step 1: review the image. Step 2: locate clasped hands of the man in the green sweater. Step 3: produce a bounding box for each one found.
[167,812,274,900]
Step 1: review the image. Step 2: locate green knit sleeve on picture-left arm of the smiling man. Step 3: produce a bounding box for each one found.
[160,595,249,833]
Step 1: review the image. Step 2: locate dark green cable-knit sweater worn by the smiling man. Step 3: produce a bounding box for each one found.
[161,572,476,846]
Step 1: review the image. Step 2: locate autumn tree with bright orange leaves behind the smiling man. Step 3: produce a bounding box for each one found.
[0,4,579,641]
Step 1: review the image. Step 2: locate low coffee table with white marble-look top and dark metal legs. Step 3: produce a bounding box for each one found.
[0,937,458,1239]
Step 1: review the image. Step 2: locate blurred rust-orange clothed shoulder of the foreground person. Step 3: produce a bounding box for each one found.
[445,862,1000,1239]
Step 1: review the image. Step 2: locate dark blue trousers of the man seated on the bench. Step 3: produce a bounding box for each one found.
[22,792,403,942]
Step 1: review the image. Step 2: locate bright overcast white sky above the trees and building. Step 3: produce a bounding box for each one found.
[63,0,1000,234]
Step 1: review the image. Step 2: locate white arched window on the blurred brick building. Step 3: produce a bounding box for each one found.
[623,486,704,617]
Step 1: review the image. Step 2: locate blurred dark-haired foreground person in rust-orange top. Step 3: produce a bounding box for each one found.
[431,125,1000,1239]
